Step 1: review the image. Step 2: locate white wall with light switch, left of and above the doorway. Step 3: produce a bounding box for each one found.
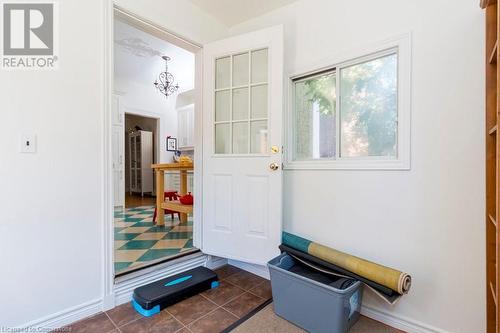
[0,0,225,326]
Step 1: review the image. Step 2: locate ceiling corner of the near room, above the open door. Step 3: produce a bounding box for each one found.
[190,0,297,27]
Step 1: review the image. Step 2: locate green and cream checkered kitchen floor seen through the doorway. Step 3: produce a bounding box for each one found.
[114,206,194,274]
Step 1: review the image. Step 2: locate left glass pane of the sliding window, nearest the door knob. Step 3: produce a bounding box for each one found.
[293,71,337,160]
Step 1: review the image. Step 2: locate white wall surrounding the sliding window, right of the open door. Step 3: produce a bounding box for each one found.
[232,0,485,333]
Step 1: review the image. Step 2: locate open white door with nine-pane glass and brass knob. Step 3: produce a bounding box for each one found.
[202,26,283,265]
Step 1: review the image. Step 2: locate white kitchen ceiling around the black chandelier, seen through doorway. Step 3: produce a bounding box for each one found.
[114,20,195,91]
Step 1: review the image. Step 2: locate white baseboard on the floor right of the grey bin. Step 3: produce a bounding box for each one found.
[361,305,449,333]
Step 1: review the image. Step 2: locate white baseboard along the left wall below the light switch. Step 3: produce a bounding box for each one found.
[16,299,102,332]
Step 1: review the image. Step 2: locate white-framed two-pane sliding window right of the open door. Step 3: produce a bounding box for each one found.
[287,37,410,169]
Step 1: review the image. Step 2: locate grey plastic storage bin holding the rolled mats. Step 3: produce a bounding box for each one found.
[268,253,363,333]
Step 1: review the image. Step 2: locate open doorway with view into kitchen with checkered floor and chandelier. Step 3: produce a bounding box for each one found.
[112,13,198,277]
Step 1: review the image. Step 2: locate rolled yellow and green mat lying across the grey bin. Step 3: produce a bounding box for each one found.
[282,232,411,294]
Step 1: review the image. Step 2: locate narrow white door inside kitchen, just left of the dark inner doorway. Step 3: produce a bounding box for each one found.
[112,126,125,206]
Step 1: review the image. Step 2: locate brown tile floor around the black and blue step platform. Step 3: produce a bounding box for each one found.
[61,266,271,333]
